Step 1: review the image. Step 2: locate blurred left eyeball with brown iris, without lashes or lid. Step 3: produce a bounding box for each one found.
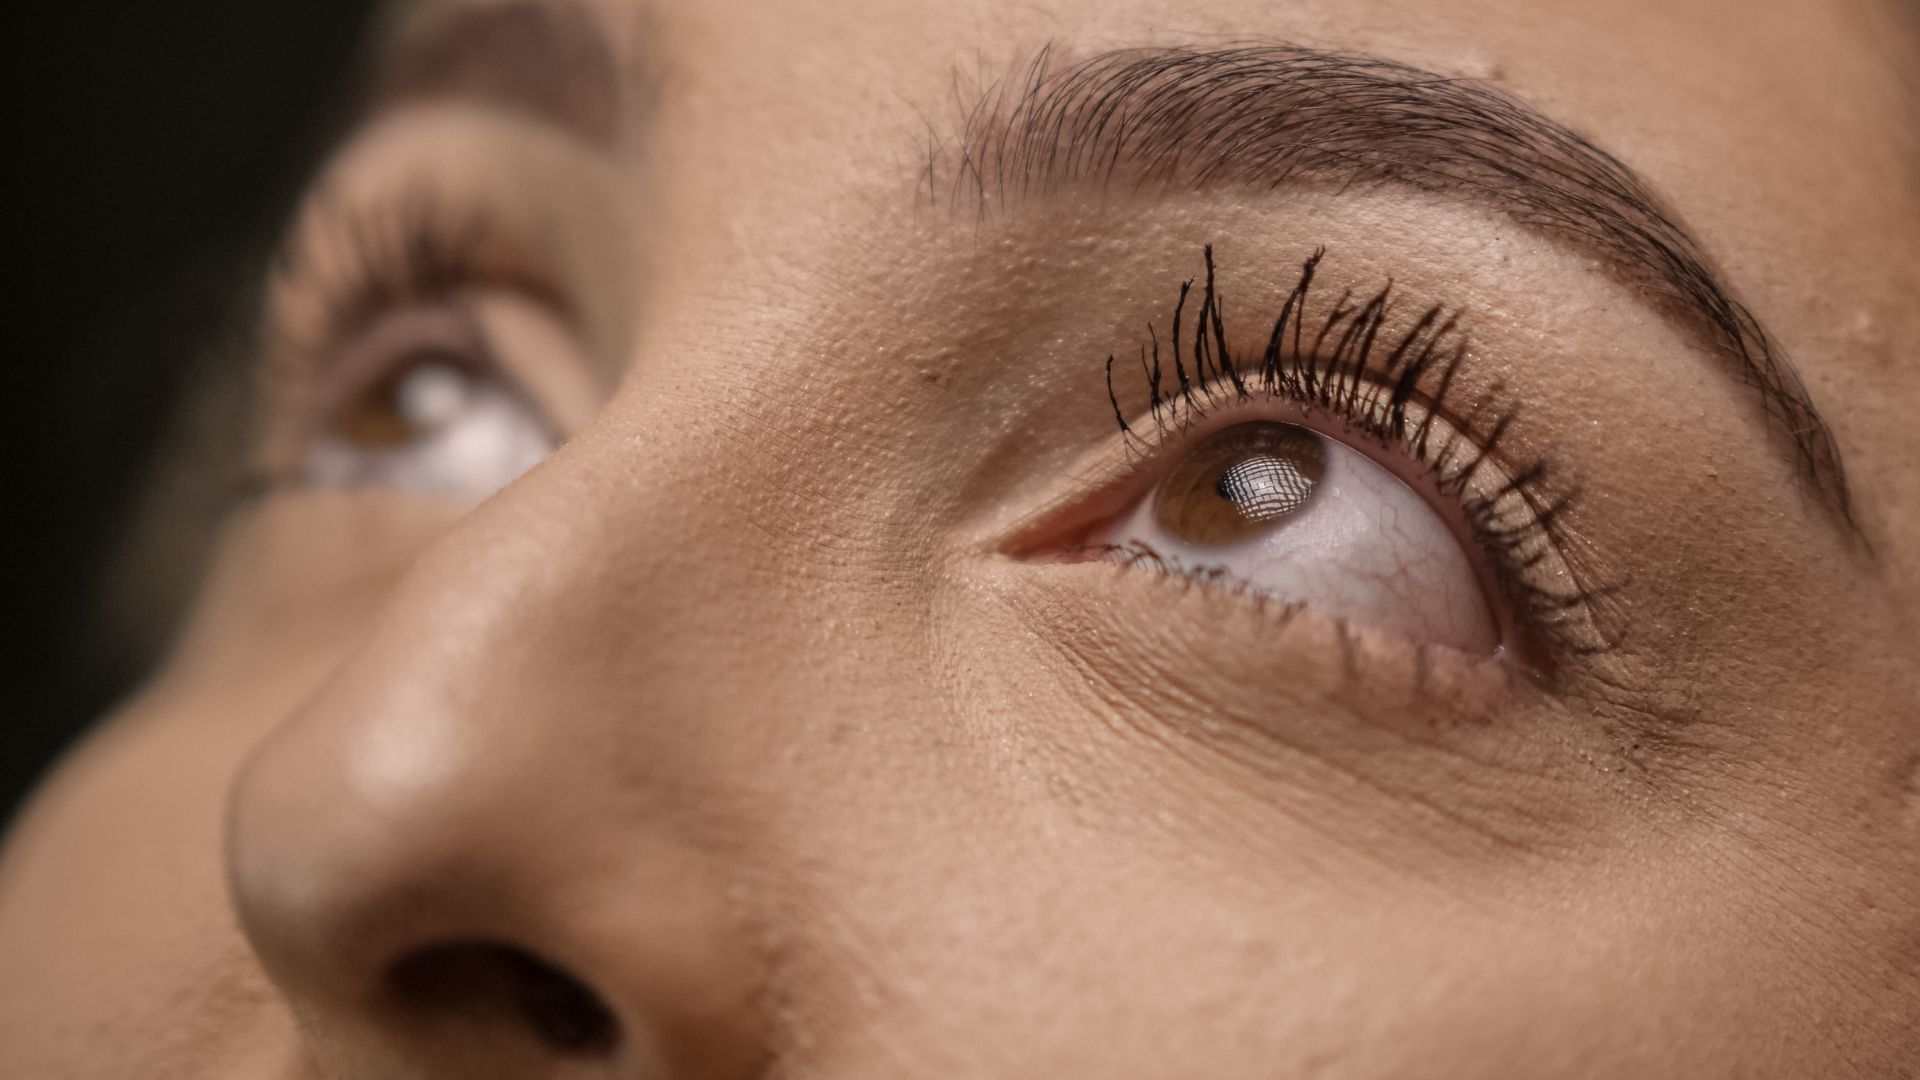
[303,297,557,496]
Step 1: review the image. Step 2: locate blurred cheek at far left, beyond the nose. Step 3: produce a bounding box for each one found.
[0,494,461,1080]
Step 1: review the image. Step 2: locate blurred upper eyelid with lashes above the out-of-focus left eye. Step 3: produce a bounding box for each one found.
[263,106,637,384]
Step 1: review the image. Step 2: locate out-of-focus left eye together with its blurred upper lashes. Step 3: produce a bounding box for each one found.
[271,186,605,496]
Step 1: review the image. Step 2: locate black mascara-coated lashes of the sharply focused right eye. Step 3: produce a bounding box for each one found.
[1106,244,1615,655]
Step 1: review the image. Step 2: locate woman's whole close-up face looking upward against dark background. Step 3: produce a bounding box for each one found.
[0,0,1920,1078]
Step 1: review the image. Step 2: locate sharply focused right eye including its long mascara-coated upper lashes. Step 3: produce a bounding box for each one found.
[1021,248,1597,669]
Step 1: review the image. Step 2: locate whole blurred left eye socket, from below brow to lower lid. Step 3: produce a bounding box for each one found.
[255,115,636,500]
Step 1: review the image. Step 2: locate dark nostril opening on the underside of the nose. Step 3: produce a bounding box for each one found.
[388,942,620,1057]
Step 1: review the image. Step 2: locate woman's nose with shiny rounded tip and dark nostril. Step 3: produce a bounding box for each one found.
[228,488,760,1078]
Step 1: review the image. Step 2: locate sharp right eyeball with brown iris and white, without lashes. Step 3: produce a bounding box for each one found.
[1091,421,1501,653]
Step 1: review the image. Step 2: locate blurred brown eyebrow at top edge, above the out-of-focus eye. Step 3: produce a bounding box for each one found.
[372,0,637,146]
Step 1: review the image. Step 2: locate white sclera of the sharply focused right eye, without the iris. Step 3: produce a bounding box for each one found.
[1094,426,1500,653]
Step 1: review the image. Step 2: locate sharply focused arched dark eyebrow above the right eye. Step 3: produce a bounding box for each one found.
[924,44,1853,528]
